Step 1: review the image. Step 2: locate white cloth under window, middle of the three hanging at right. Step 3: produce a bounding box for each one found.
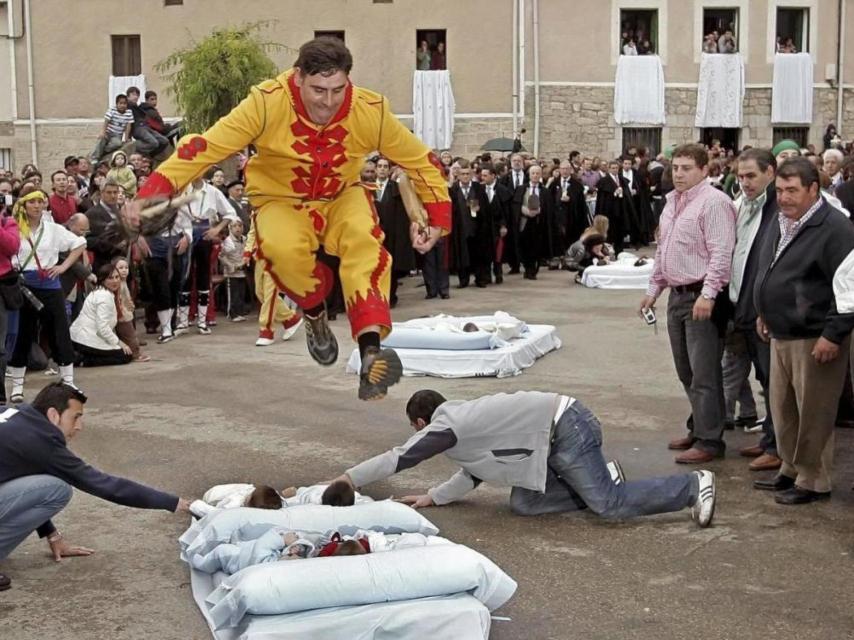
[694,53,744,129]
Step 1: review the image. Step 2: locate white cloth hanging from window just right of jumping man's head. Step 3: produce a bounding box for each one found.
[412,71,456,149]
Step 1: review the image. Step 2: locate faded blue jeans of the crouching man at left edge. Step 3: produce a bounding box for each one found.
[0,475,71,560]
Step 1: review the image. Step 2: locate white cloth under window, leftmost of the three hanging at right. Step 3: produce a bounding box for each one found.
[614,56,664,124]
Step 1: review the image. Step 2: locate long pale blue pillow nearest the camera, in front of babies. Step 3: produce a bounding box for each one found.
[206,544,516,629]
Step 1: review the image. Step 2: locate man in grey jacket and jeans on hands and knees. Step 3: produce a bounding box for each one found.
[338,390,715,527]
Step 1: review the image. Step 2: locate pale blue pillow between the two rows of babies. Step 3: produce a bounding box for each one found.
[179,500,439,561]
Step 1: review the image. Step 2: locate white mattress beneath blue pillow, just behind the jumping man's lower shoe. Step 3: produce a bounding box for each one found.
[346,324,561,378]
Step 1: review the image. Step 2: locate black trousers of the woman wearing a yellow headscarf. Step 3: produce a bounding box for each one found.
[9,288,74,367]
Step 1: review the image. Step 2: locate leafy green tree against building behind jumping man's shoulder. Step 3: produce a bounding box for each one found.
[159,22,289,133]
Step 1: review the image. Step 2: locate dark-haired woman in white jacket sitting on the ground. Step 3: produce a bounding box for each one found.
[71,264,133,367]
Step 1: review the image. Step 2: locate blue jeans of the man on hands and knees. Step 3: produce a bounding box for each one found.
[510,400,699,518]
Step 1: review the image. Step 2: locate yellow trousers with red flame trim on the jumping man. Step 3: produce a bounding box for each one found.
[255,185,391,338]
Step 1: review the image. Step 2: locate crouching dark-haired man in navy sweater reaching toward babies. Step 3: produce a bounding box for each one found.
[0,382,189,591]
